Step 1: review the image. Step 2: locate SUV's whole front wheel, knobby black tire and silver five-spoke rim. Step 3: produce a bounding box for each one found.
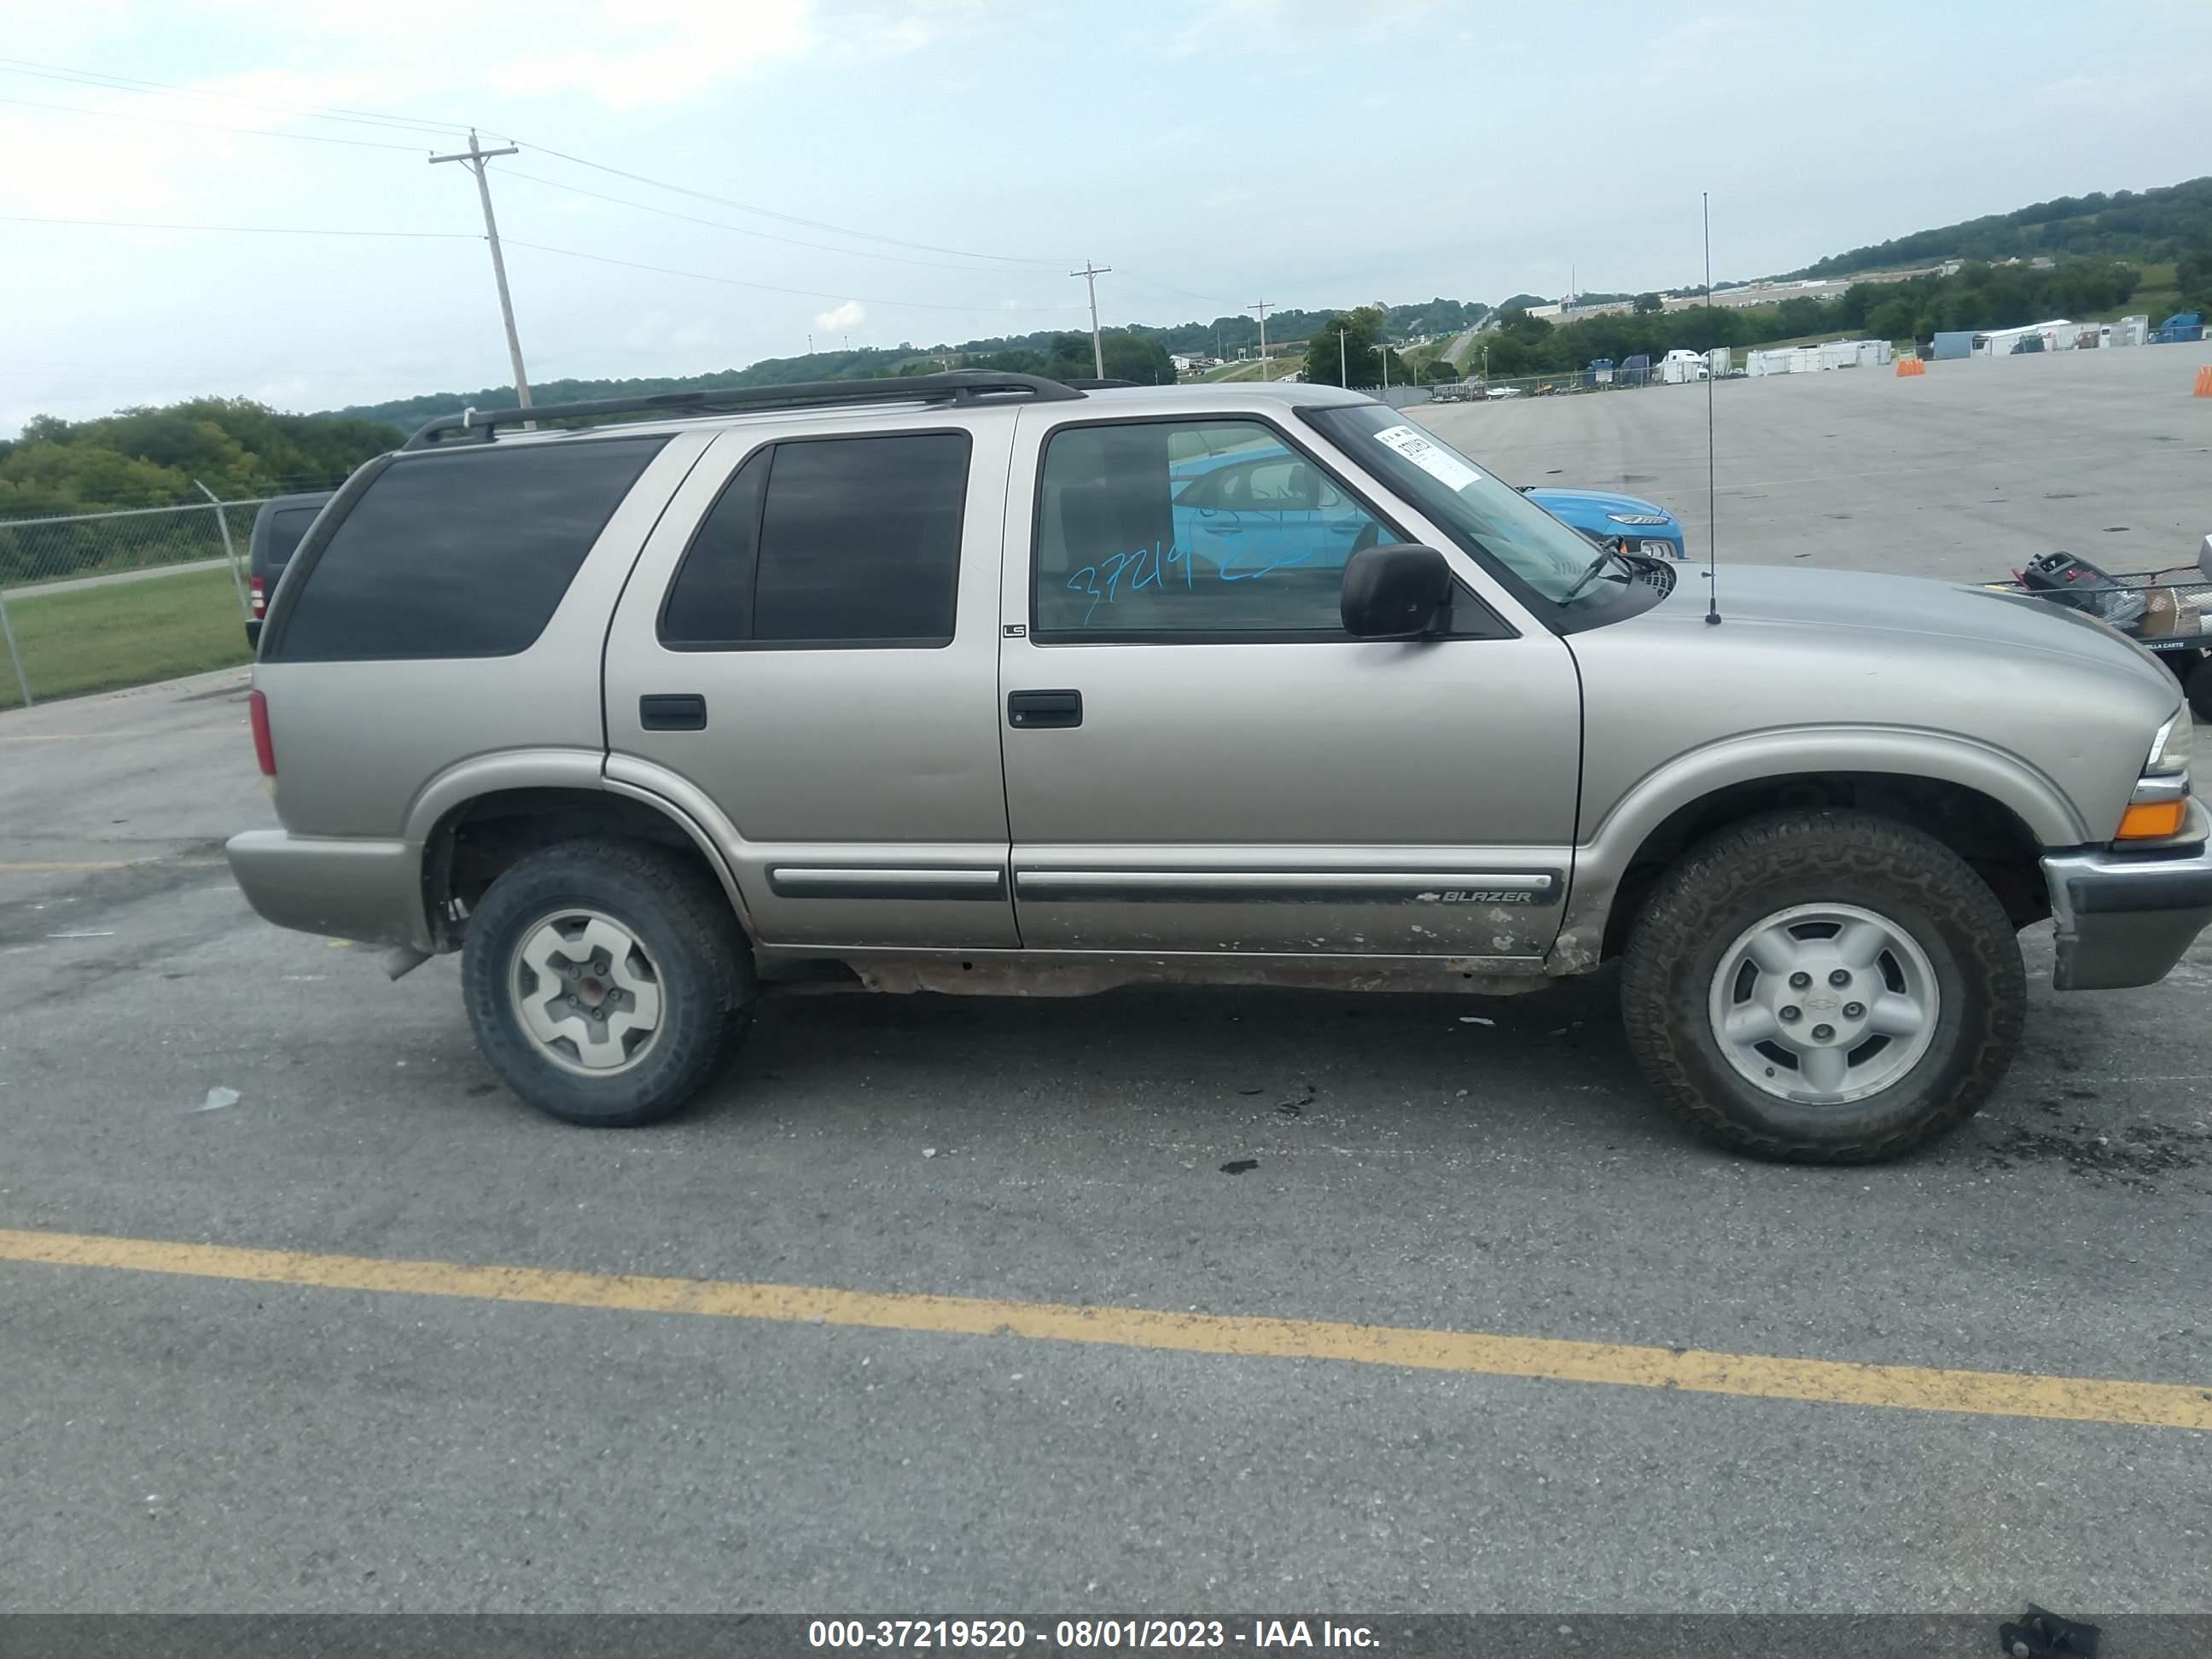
[1621,812,2026,1163]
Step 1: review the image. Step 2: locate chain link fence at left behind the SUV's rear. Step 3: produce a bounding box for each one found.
[0,486,285,707]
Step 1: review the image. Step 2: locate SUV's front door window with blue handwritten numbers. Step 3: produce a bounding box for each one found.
[1035,420,1398,639]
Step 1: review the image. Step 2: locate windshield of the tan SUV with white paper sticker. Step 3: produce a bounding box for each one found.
[1301,403,1619,604]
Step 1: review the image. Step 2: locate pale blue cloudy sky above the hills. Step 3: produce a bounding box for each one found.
[0,0,2212,436]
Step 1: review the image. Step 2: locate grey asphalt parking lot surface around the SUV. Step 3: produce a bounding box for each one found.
[0,350,2212,1613]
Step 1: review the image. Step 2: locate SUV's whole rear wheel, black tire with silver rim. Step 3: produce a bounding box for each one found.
[463,841,756,1128]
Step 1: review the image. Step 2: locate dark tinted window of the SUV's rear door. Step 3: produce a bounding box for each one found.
[659,431,969,650]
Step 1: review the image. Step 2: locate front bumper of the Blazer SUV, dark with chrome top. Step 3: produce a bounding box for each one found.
[2041,803,2212,991]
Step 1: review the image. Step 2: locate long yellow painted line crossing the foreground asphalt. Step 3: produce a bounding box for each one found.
[0,1232,2212,1431]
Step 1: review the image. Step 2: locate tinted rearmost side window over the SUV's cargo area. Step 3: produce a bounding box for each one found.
[265,438,668,661]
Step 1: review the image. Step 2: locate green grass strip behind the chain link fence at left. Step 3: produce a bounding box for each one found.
[0,571,252,707]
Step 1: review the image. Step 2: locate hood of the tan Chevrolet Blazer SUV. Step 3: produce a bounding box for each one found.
[1621,564,2181,703]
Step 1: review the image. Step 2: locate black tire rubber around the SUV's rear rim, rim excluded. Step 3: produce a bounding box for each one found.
[460,838,759,1128]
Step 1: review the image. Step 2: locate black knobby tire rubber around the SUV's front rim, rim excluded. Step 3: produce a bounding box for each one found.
[1621,810,2026,1163]
